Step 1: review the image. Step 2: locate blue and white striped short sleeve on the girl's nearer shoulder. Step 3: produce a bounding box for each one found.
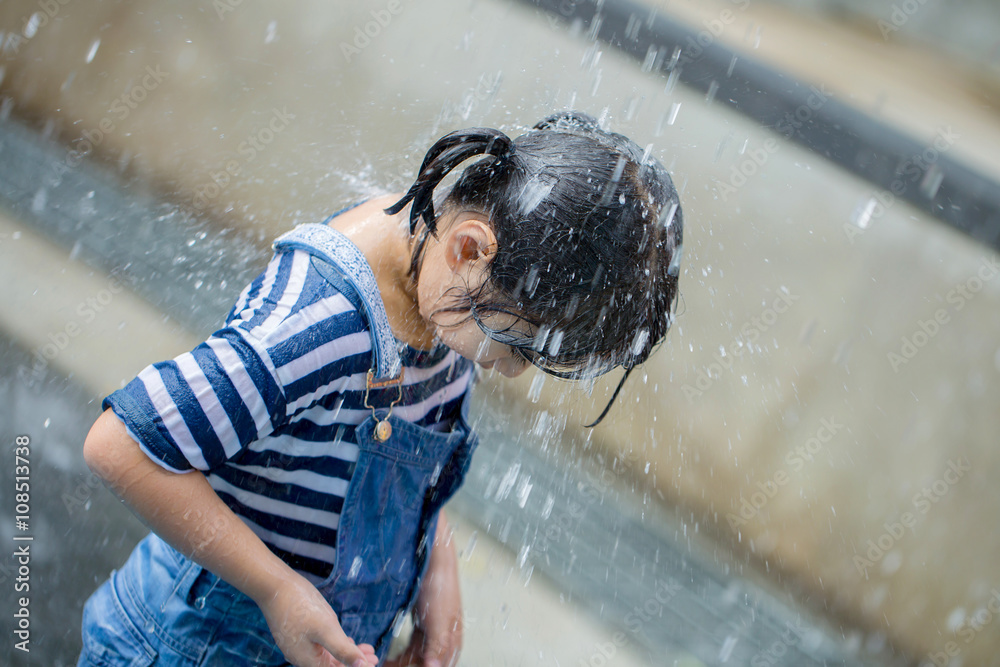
[102,251,370,472]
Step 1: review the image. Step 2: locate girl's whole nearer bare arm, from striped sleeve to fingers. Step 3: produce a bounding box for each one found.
[83,409,376,667]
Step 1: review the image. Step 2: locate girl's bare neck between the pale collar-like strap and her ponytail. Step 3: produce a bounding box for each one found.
[329,194,436,350]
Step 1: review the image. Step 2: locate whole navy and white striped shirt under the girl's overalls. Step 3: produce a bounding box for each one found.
[103,250,473,583]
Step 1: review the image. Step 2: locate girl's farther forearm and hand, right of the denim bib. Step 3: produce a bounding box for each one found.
[385,513,462,667]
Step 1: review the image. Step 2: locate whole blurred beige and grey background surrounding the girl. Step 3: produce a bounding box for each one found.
[0,0,1000,667]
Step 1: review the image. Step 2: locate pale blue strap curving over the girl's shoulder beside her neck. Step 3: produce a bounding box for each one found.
[271,223,403,381]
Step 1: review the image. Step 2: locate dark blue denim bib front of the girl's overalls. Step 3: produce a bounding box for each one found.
[319,397,475,658]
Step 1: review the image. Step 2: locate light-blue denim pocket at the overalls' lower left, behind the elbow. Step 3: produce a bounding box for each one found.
[79,573,156,667]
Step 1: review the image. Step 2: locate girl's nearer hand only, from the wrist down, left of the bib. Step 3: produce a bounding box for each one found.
[257,574,378,667]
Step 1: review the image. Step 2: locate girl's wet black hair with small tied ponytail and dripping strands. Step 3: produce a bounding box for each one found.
[385,112,683,427]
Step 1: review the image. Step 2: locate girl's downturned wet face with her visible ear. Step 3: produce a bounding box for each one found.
[417,213,531,377]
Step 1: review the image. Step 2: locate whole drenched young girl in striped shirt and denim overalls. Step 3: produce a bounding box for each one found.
[79,113,682,667]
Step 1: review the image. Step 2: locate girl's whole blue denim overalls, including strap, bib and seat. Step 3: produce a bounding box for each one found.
[79,222,477,667]
